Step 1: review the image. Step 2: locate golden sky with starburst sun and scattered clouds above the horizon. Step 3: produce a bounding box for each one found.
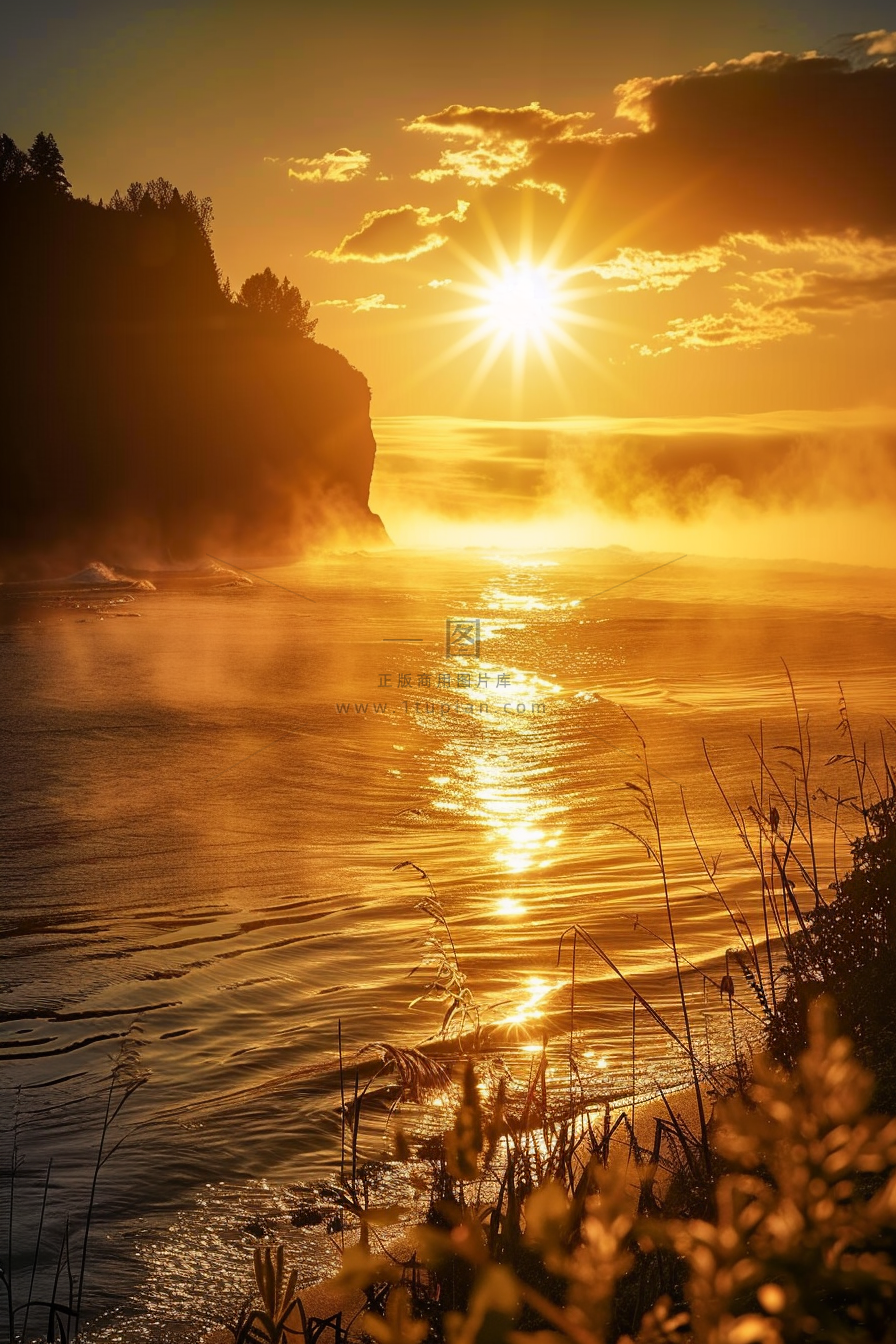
[0,0,896,563]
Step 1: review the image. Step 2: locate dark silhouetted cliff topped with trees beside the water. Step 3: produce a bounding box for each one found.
[0,137,386,577]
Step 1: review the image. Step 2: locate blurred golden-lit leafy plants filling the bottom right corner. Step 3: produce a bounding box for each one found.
[235,1000,896,1344]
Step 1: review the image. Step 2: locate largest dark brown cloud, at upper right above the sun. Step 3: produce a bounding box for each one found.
[521,51,896,252]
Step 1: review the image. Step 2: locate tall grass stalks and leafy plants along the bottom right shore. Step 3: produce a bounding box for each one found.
[228,698,896,1344]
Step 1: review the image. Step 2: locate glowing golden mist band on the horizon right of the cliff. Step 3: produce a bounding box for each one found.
[371,419,896,566]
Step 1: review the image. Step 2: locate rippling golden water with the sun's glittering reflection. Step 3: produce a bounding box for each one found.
[0,550,896,1340]
